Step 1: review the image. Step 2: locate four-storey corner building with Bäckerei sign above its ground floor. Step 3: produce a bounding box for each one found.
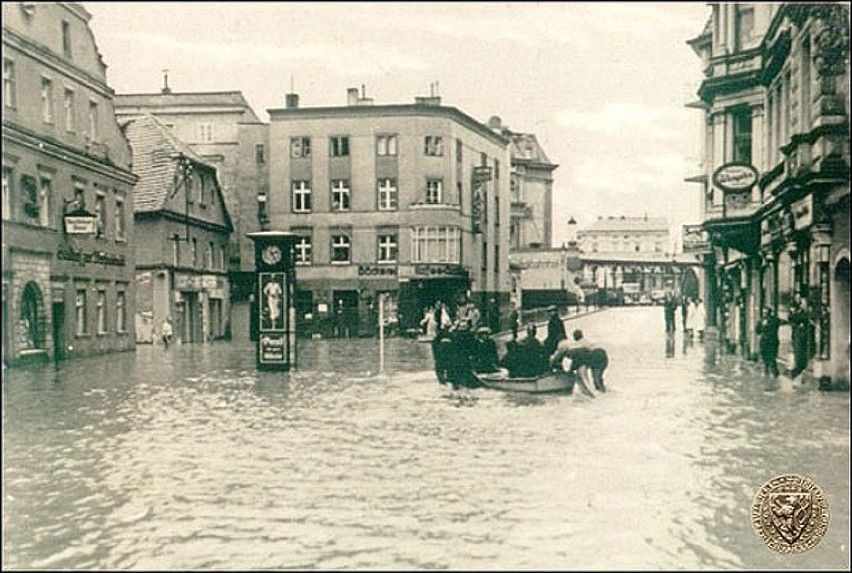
[266,89,509,335]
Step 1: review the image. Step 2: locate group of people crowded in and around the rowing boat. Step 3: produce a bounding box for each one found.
[432,306,609,392]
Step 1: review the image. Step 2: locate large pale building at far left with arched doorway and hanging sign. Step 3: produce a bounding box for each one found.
[2,2,136,364]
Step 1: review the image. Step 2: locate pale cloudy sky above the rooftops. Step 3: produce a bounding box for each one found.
[83,2,710,246]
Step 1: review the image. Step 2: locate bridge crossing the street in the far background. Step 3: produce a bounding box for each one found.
[575,252,705,304]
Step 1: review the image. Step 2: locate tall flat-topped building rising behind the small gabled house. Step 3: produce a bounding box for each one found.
[116,87,269,339]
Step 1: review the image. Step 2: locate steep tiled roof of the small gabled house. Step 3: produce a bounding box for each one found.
[124,113,216,213]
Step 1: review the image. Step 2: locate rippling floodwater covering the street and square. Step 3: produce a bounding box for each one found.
[3,307,850,569]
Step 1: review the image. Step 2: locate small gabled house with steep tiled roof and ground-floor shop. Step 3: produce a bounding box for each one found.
[122,114,233,342]
